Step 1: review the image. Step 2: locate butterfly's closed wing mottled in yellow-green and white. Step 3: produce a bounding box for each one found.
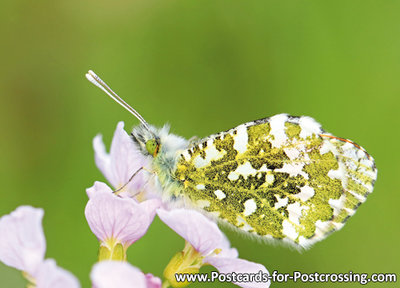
[174,114,377,247]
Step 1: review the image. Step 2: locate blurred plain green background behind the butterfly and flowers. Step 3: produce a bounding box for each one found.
[0,0,400,287]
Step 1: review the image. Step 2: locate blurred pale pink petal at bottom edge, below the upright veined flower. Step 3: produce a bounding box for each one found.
[90,261,146,288]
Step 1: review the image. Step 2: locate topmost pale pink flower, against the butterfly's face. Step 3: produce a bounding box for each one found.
[93,122,149,194]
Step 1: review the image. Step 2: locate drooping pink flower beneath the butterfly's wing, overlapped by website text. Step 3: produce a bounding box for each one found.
[157,209,270,288]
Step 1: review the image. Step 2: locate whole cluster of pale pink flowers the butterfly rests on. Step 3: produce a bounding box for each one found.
[0,122,269,288]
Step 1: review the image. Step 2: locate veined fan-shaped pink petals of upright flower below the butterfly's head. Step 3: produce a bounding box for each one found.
[85,184,154,246]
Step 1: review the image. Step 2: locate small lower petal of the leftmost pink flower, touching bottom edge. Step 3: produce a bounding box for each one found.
[32,259,81,288]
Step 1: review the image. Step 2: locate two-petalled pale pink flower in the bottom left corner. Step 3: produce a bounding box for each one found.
[0,206,80,288]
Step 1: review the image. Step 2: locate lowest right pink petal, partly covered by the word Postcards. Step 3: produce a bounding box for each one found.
[203,255,271,288]
